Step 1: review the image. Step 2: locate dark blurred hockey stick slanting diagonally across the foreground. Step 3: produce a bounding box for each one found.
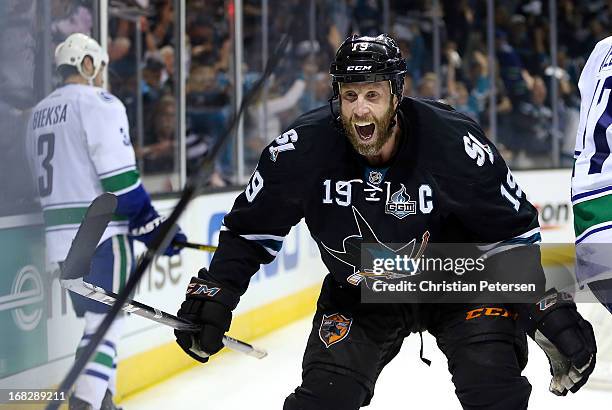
[47,34,289,410]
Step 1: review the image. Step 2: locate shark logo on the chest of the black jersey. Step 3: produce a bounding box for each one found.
[321,206,429,286]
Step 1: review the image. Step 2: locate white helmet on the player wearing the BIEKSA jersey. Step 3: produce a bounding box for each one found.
[55,33,108,81]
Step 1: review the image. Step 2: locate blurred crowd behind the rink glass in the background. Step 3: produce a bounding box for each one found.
[0,0,612,207]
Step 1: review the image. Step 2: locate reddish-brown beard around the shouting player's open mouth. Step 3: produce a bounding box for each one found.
[340,97,395,156]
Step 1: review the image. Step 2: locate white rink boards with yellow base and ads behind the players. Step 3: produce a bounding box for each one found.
[0,170,573,402]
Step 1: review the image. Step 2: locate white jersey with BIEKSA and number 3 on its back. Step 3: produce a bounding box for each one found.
[28,84,140,262]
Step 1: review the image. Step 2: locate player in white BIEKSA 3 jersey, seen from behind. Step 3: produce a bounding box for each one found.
[28,33,186,410]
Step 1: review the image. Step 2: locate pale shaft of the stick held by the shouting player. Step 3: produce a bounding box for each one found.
[62,279,268,359]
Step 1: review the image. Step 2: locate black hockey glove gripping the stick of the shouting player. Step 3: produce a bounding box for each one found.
[174,268,239,363]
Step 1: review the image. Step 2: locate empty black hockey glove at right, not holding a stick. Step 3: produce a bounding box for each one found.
[527,289,597,396]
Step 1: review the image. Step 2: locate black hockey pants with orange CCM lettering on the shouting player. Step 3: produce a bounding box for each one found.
[283,276,531,410]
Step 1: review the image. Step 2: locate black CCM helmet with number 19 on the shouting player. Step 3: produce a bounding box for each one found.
[329,34,407,99]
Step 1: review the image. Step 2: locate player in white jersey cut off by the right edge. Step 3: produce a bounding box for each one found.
[572,37,612,313]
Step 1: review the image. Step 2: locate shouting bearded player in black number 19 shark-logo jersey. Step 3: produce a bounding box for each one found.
[176,35,596,410]
